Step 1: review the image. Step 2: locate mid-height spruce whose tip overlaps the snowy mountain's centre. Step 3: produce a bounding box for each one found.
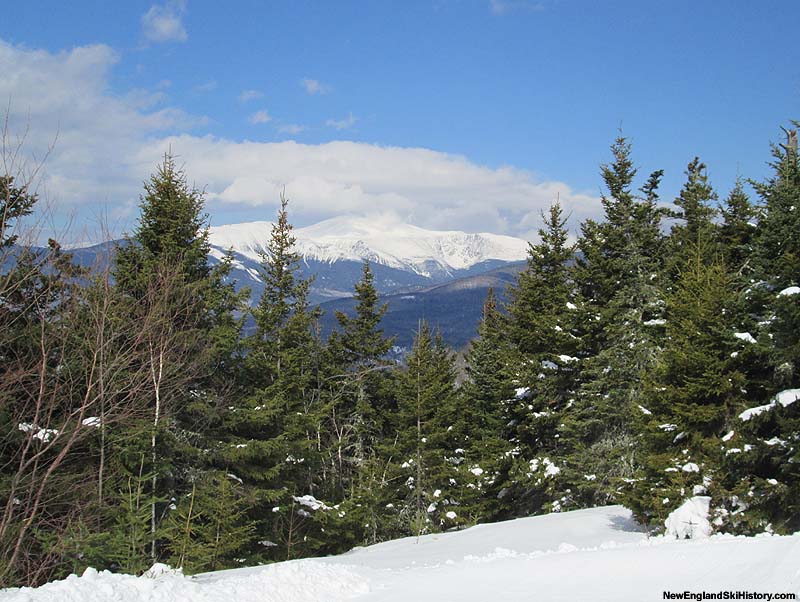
[314,261,395,552]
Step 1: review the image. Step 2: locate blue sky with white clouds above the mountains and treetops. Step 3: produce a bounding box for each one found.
[0,0,800,244]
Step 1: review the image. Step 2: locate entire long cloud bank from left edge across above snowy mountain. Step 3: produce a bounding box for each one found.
[0,36,601,239]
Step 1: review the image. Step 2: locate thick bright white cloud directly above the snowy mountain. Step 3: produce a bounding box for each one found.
[143,135,600,234]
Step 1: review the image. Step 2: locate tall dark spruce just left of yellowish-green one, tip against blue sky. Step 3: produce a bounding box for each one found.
[562,138,663,505]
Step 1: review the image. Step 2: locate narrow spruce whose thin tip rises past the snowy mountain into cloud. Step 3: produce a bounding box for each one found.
[218,196,322,561]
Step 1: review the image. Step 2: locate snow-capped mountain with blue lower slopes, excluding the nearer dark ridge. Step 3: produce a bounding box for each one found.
[210,216,528,303]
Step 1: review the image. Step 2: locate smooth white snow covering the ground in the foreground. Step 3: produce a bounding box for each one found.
[0,506,800,602]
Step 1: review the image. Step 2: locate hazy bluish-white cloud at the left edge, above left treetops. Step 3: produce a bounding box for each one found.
[0,40,201,217]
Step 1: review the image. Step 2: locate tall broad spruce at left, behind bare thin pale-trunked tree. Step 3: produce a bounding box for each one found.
[113,154,246,560]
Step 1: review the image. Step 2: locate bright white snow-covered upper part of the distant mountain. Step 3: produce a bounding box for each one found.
[210,216,528,276]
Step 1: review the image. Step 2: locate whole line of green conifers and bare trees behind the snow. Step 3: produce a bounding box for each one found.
[0,130,800,586]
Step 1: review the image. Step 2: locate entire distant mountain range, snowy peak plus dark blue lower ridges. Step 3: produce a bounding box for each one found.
[53,217,528,349]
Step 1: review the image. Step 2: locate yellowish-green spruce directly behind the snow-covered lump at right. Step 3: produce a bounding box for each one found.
[626,242,745,526]
